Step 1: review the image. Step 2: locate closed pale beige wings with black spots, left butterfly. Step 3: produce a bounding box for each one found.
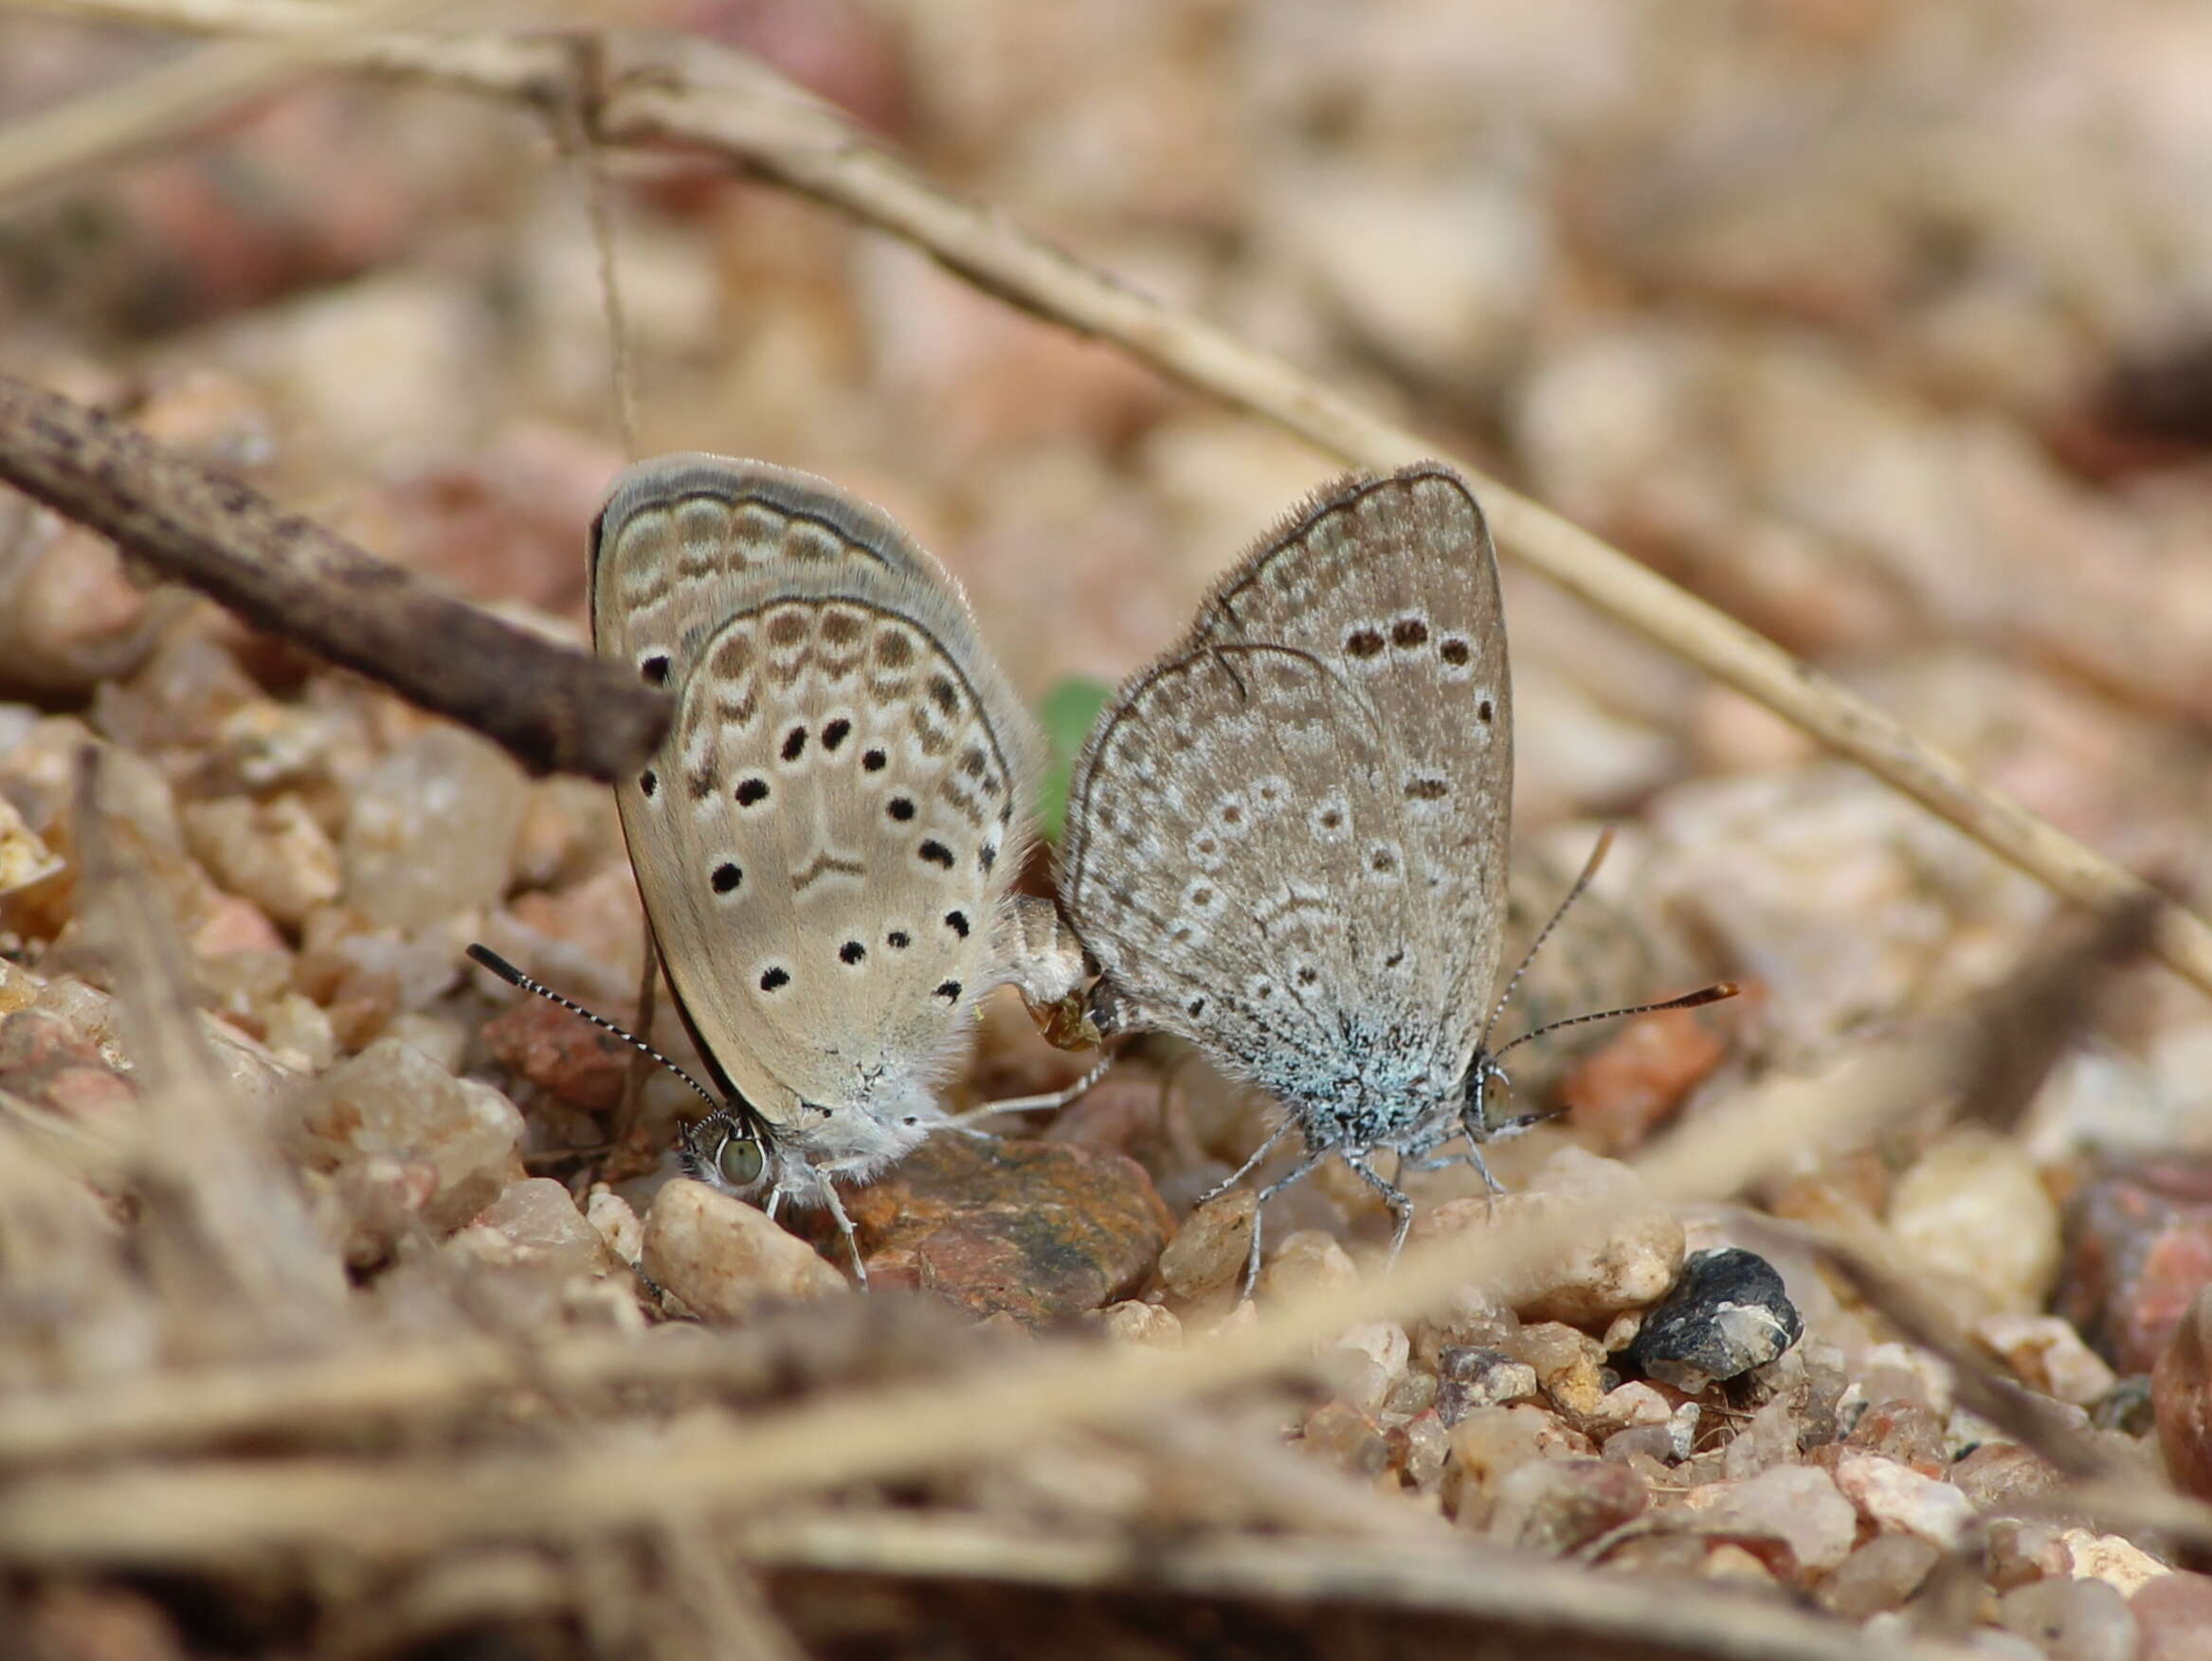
[593,458,1035,1152]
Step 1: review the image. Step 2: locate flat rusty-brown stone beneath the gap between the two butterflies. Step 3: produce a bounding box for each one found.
[831,1134,1174,1325]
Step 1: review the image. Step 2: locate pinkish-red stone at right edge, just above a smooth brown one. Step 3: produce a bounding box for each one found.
[2055,1157,2212,1376]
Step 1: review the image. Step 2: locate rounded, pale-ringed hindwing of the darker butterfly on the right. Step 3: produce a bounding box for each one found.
[1061,643,1406,1088]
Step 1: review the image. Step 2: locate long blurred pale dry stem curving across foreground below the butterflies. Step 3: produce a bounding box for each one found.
[0,911,2123,1566]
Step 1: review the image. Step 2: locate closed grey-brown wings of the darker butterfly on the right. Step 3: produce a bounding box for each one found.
[1061,464,1513,1097]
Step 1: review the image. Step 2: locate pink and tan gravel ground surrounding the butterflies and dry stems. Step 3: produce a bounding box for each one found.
[12,0,2212,1656]
